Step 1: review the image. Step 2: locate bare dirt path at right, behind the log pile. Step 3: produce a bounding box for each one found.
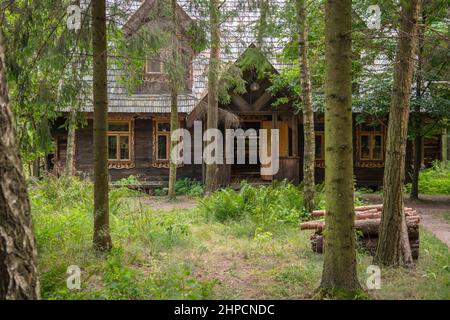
[363,194,450,248]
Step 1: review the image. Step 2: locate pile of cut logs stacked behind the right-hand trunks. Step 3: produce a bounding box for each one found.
[300,205,420,260]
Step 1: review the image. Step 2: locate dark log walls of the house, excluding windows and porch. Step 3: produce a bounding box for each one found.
[52,114,440,187]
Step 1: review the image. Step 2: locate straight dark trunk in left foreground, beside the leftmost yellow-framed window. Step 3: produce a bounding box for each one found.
[92,0,112,251]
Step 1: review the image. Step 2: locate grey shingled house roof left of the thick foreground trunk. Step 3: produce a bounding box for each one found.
[81,0,283,113]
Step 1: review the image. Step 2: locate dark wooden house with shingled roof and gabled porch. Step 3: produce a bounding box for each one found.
[52,0,440,186]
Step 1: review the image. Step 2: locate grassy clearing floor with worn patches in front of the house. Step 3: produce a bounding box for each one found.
[31,179,450,299]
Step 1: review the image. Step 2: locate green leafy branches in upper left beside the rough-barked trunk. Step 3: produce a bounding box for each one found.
[0,0,90,163]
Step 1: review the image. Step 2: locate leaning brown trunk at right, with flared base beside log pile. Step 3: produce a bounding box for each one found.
[375,0,420,267]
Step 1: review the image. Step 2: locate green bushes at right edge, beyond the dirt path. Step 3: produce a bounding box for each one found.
[406,161,450,194]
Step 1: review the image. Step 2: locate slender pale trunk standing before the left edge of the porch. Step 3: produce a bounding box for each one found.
[205,0,220,193]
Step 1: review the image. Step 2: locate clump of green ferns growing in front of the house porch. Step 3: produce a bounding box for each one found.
[200,182,310,232]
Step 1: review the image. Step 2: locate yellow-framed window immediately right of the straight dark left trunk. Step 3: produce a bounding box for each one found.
[108,121,131,161]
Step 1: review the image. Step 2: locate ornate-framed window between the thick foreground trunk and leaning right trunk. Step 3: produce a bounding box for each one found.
[359,124,384,161]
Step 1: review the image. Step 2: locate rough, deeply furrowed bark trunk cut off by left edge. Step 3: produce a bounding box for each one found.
[0,33,40,300]
